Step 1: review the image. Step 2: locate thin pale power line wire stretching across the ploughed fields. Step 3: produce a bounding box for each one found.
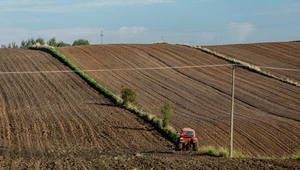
[0,64,300,75]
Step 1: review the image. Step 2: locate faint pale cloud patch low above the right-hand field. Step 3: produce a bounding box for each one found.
[228,23,255,42]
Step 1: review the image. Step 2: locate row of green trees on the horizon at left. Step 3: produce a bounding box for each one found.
[2,37,90,48]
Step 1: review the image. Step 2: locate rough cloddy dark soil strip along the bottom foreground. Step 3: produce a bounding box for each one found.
[0,152,300,170]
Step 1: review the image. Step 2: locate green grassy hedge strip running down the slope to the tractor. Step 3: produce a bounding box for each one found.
[29,46,179,143]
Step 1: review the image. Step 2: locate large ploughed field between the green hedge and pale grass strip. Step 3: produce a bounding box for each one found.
[57,44,300,156]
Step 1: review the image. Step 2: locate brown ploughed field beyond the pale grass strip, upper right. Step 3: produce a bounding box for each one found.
[207,42,300,83]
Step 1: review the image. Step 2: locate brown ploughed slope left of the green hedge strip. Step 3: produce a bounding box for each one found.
[0,49,172,158]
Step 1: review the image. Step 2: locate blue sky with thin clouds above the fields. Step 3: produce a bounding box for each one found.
[0,0,300,45]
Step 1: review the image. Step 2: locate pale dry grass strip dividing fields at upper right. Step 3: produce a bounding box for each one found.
[177,44,300,87]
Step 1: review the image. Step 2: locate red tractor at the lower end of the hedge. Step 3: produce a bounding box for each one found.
[176,128,198,151]
